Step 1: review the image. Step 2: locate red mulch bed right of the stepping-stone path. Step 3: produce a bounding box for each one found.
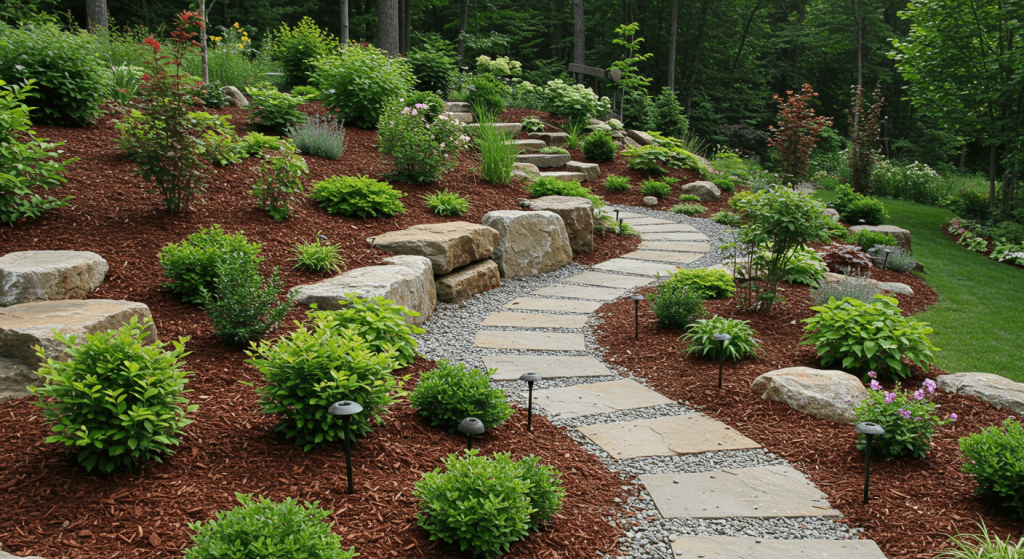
[597,272,1024,559]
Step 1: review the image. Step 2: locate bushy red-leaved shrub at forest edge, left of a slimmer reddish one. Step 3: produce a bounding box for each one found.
[768,84,831,178]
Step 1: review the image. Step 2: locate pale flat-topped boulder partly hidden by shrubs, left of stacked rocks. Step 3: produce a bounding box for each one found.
[292,255,437,326]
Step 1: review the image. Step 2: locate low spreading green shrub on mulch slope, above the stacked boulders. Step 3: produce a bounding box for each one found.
[309,176,406,219]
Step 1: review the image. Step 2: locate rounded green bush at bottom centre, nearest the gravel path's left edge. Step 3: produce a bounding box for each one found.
[413,449,565,557]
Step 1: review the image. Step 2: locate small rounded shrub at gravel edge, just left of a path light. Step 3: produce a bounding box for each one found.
[409,359,512,433]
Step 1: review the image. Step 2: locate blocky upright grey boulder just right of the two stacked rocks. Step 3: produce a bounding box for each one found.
[482,210,572,277]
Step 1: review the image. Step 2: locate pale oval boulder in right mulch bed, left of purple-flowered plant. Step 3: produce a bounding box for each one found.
[751,367,867,424]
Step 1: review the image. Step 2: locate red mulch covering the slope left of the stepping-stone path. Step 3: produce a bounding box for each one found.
[0,104,639,559]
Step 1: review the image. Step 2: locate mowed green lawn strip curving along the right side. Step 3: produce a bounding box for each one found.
[818,190,1024,382]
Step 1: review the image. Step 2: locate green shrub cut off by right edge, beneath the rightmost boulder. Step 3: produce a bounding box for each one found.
[959,418,1024,518]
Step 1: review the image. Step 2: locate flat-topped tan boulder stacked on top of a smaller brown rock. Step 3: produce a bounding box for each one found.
[373,221,499,275]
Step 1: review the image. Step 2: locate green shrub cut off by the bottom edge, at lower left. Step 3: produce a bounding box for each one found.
[184,492,358,559]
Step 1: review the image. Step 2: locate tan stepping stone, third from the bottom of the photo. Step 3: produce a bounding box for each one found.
[580,414,761,460]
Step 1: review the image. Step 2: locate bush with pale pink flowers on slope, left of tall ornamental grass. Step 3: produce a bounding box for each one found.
[378,99,469,184]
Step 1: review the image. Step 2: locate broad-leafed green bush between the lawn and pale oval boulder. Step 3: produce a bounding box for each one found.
[800,295,938,379]
